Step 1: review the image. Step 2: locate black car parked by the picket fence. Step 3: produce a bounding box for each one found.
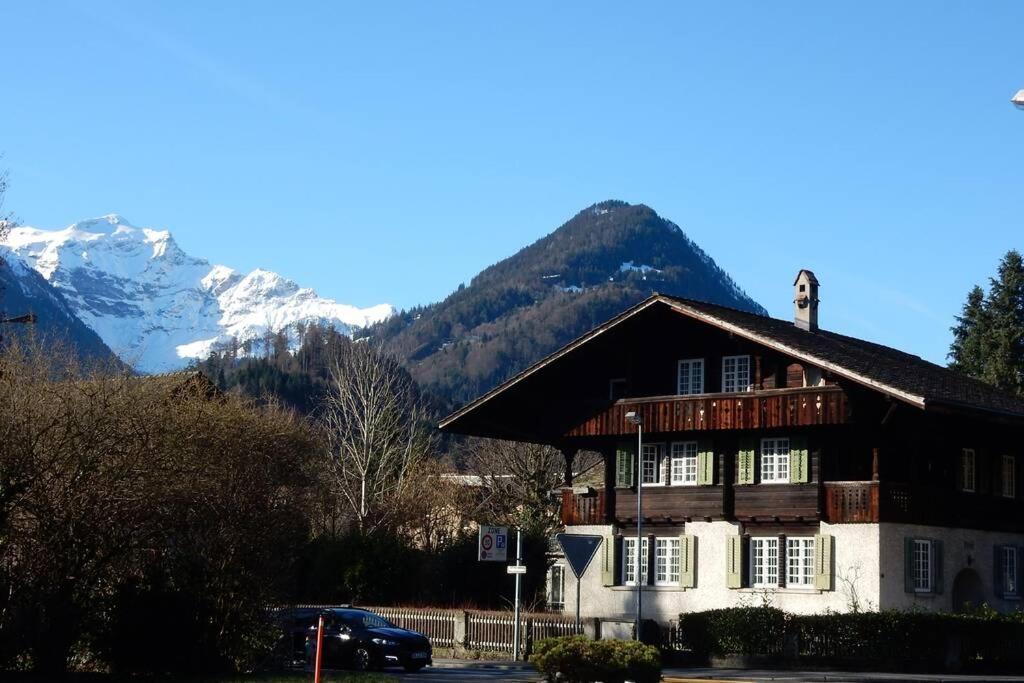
[306,608,433,671]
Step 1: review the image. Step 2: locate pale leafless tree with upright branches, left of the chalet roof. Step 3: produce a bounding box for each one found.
[319,342,433,533]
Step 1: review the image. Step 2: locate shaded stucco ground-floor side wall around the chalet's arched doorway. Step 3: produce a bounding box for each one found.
[880,523,1024,611]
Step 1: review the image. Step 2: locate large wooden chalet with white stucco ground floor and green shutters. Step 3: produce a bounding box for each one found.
[441,270,1024,622]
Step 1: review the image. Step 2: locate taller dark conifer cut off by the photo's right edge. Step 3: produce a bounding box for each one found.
[982,250,1024,395]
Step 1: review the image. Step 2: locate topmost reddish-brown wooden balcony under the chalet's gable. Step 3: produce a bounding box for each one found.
[566,386,849,436]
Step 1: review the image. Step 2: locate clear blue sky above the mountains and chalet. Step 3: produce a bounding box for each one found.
[0,1,1024,361]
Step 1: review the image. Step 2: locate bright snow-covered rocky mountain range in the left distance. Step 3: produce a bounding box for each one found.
[5,214,394,373]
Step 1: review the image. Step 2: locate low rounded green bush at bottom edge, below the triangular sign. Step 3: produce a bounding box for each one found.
[530,636,662,683]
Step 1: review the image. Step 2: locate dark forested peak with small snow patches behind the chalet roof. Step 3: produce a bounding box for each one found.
[358,201,765,408]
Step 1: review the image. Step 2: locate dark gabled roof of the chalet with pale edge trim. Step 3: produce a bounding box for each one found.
[440,294,1024,431]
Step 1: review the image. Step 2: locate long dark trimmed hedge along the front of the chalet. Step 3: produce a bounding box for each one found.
[674,606,1024,670]
